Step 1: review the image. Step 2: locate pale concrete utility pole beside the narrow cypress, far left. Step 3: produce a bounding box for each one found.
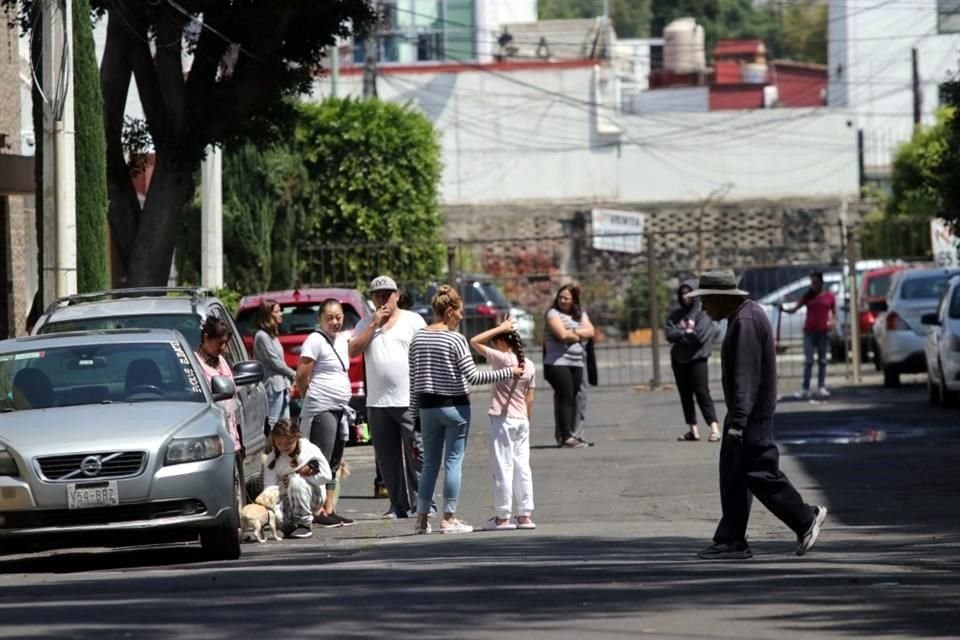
[41,0,77,304]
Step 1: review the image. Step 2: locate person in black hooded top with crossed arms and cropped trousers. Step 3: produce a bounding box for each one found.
[664,280,720,442]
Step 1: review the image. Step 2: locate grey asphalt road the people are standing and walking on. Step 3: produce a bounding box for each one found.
[0,378,960,640]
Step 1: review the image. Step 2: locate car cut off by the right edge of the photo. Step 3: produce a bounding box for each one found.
[921,276,960,407]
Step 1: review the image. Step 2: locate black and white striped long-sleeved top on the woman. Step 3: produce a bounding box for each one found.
[410,329,513,415]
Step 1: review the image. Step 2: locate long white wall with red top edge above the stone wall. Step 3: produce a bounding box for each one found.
[314,66,858,204]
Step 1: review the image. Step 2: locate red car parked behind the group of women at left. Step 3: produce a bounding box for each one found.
[237,288,372,422]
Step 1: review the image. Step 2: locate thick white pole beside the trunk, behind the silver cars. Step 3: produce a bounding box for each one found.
[200,145,223,289]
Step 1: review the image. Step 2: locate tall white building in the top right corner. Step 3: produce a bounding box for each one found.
[828,0,960,170]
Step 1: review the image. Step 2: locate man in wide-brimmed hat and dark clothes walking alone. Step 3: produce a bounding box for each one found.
[687,271,827,560]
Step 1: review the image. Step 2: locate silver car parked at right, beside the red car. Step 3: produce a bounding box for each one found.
[873,268,960,387]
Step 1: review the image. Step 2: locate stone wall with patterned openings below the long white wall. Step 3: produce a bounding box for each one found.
[444,200,865,330]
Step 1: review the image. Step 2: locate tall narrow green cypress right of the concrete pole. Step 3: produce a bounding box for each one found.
[73,0,107,292]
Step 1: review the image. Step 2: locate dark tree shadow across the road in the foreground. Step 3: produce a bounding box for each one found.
[0,533,960,639]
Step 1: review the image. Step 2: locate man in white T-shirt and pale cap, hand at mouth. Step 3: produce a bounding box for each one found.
[349,276,426,518]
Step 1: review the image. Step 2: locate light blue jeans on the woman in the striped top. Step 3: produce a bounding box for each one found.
[417,405,470,515]
